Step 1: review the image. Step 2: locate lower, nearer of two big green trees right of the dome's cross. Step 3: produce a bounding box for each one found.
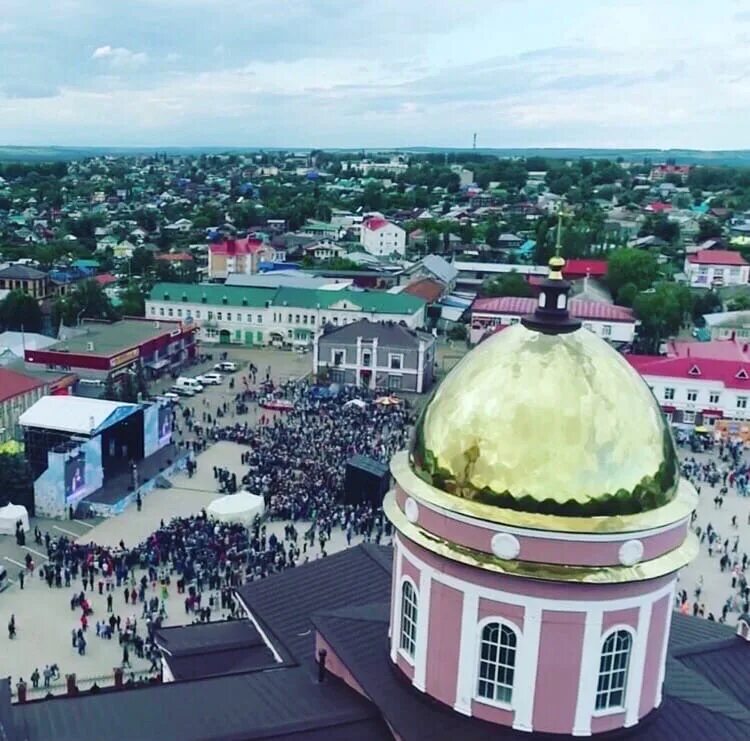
[633,283,693,353]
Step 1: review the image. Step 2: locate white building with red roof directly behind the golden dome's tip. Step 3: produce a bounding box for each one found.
[469,296,637,345]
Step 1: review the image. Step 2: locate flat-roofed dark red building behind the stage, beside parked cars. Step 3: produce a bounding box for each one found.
[24,318,196,385]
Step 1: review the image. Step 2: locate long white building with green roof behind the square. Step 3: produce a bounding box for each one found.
[146,283,425,347]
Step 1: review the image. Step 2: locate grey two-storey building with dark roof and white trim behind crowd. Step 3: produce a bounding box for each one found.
[313,319,435,393]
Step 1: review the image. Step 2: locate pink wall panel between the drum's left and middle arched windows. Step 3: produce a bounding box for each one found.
[425,582,463,707]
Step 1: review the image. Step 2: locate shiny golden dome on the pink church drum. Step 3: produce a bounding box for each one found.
[411,324,679,516]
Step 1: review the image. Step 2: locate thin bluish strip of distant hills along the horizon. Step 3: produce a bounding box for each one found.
[0,146,750,167]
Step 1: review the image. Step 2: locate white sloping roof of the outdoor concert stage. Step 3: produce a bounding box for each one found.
[18,396,140,435]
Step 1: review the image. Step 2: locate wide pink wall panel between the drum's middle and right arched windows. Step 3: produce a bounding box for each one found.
[533,610,586,733]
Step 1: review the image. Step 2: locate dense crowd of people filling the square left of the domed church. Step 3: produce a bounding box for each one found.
[8,376,413,687]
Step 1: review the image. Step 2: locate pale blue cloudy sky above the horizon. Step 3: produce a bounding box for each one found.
[0,0,750,149]
